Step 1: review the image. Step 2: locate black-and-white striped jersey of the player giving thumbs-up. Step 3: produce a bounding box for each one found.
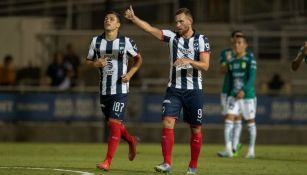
[162,30,210,89]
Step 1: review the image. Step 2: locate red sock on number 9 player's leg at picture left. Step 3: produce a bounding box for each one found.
[161,128,174,165]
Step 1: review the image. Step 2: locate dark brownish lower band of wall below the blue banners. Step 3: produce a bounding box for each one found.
[0,122,307,145]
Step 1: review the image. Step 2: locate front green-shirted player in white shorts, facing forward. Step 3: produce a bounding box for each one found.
[225,35,257,158]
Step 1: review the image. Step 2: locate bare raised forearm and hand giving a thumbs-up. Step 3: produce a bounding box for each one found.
[125,5,162,40]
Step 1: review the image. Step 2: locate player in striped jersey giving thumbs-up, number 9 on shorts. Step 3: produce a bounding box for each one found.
[125,6,210,174]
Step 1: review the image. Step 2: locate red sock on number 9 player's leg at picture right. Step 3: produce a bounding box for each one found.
[189,132,202,168]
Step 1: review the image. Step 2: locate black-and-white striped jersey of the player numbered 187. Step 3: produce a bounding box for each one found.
[87,36,138,95]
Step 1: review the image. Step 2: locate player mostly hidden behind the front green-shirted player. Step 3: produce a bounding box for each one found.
[217,30,254,157]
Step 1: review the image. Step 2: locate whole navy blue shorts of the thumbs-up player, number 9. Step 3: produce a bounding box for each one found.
[162,87,204,125]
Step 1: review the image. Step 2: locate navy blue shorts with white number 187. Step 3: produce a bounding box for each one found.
[100,94,128,121]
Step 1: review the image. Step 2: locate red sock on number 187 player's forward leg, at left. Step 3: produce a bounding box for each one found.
[106,122,121,164]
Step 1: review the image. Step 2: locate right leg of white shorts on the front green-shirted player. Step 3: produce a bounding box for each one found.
[240,99,256,120]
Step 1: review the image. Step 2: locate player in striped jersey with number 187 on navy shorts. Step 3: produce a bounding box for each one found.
[87,11,142,171]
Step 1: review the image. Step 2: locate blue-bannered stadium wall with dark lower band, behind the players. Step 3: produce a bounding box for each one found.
[0,91,307,144]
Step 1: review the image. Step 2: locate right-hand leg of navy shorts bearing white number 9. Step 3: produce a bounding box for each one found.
[182,90,204,125]
